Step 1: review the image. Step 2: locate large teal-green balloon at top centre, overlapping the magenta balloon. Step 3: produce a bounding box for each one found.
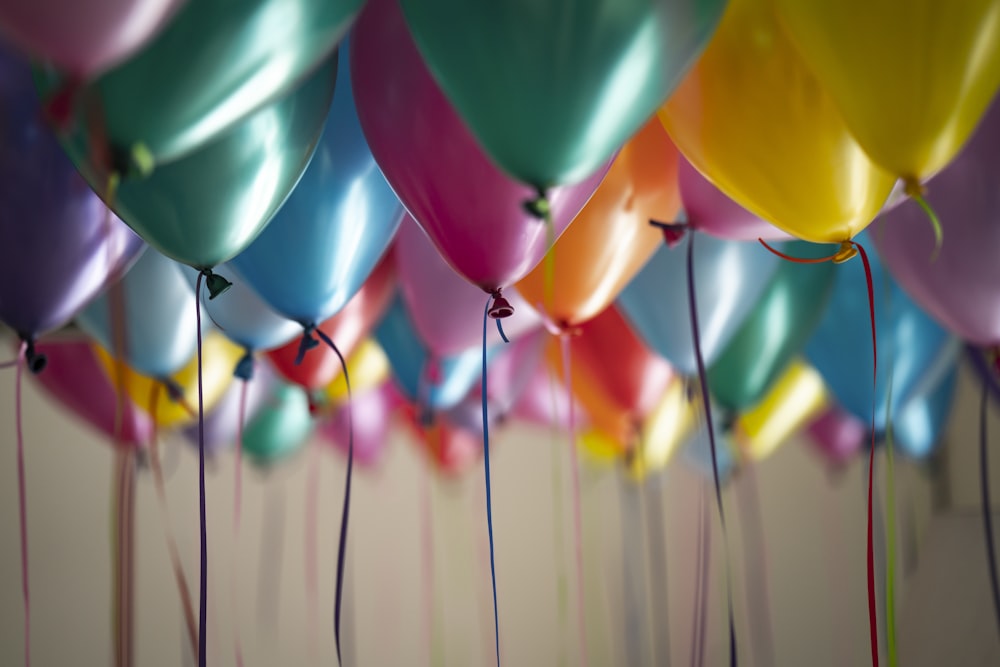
[396,0,726,188]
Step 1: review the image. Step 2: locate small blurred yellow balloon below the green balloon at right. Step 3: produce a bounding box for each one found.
[733,361,827,461]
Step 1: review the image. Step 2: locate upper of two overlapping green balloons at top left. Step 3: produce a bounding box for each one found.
[41,0,363,168]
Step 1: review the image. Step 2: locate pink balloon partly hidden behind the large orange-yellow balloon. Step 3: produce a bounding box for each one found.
[677,156,791,241]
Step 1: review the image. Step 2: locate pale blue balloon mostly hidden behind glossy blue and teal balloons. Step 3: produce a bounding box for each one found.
[184,264,302,352]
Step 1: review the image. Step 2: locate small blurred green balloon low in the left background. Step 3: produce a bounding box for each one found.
[243,384,313,464]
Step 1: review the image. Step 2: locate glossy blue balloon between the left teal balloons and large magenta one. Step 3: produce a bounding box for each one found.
[232,43,403,326]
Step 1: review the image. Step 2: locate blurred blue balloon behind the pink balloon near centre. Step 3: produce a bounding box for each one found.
[375,295,501,410]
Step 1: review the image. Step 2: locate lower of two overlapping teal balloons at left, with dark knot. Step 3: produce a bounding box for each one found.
[84,57,337,269]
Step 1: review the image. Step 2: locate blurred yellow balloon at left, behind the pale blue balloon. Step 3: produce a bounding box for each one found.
[94,332,243,428]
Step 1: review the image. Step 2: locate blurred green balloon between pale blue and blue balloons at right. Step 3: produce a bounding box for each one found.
[708,242,837,412]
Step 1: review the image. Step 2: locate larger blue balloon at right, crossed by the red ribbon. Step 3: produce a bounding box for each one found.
[805,234,959,432]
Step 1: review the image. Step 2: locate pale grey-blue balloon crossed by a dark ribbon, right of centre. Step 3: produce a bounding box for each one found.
[618,234,778,375]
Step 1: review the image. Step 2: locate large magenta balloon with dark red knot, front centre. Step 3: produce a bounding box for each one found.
[350,0,604,291]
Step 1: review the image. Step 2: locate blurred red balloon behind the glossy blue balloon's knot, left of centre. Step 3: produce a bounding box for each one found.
[267,256,396,391]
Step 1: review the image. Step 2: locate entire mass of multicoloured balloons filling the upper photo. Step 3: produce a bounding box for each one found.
[0,0,1000,477]
